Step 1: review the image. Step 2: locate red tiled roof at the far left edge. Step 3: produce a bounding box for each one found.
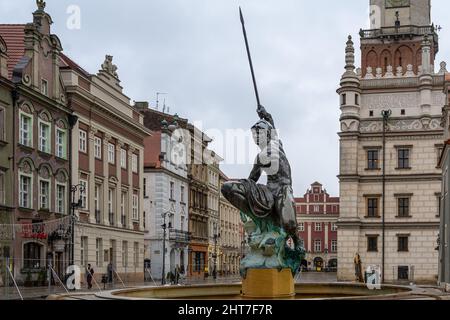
[0,24,25,79]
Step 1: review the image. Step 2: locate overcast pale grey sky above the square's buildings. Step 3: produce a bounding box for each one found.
[0,0,450,196]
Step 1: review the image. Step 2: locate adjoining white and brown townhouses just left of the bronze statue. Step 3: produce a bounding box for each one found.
[135,102,241,279]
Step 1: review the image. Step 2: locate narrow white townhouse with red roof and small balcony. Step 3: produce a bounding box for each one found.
[144,122,189,279]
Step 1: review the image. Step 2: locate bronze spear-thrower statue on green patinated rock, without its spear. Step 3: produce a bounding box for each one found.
[222,106,305,278]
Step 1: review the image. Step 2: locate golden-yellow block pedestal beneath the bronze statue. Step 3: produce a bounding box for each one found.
[242,269,295,299]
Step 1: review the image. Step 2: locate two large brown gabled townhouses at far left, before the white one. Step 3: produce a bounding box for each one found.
[0,2,150,283]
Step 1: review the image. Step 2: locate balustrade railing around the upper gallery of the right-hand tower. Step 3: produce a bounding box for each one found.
[359,25,437,39]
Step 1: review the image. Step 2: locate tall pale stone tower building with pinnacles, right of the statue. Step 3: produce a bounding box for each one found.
[337,0,445,282]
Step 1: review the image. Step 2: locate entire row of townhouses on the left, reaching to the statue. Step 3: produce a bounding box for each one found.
[0,2,244,285]
